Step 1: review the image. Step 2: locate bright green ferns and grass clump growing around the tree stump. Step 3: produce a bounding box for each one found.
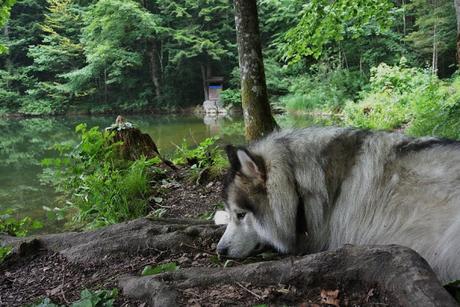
[43,124,159,228]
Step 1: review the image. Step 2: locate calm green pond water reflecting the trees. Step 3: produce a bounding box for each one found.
[0,115,324,231]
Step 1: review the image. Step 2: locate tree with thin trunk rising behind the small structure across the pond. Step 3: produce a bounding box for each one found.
[160,0,236,100]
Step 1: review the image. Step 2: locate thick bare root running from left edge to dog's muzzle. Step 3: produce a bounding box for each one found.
[0,218,223,264]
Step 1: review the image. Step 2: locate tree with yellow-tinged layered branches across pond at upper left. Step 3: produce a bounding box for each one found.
[23,0,85,112]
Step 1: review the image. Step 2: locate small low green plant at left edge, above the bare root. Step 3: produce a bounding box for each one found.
[0,209,43,237]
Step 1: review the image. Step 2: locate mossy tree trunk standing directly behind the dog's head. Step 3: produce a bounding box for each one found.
[233,0,277,141]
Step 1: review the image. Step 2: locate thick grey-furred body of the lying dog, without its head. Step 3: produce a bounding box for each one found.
[249,128,460,281]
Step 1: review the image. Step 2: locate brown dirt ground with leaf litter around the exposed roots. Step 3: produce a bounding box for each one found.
[0,170,402,306]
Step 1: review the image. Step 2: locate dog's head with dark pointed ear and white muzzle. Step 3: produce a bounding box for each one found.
[215,146,295,258]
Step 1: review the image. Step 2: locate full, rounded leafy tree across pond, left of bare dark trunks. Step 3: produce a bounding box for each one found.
[64,0,164,105]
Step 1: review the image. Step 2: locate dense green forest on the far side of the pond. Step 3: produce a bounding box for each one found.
[0,0,460,142]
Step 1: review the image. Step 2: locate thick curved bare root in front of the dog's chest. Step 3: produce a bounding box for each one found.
[120,245,458,307]
